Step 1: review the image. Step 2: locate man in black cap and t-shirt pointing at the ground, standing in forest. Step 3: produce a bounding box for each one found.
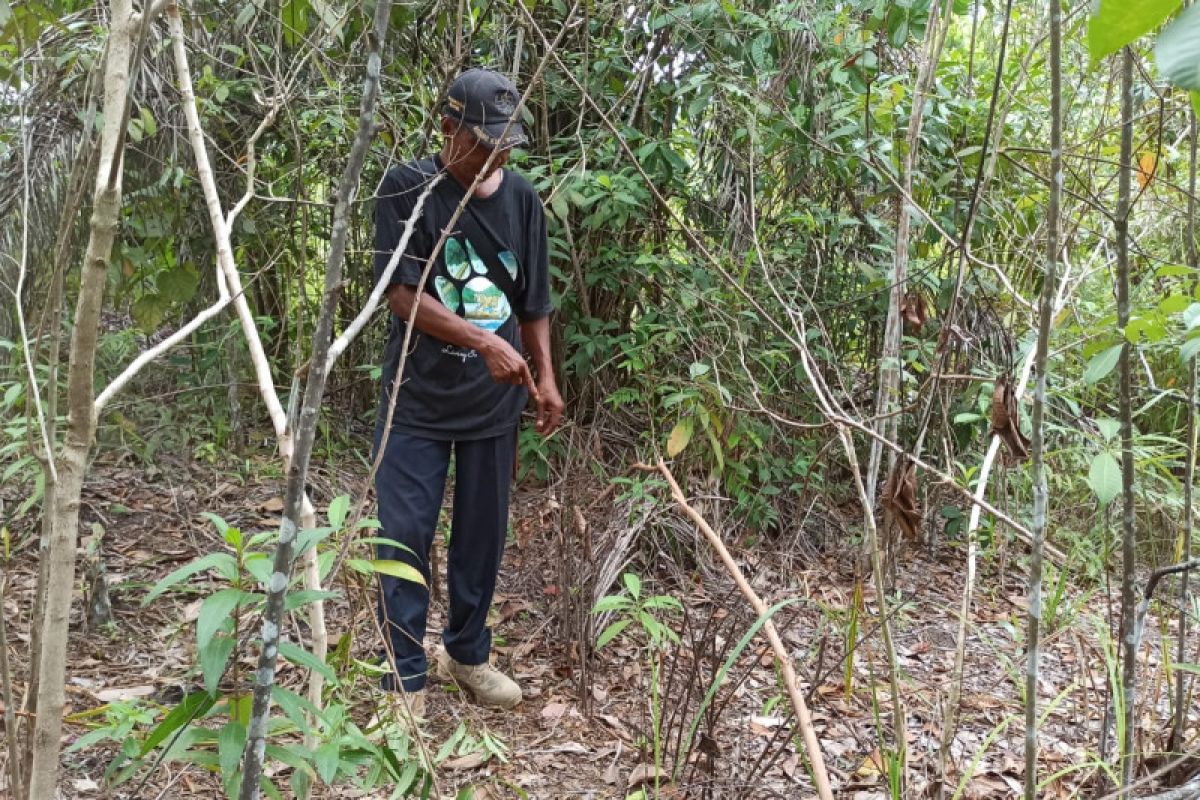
[374,70,563,716]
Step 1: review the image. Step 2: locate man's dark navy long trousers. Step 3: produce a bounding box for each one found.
[373,426,516,692]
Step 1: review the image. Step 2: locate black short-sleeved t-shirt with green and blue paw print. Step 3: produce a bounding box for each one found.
[374,158,553,439]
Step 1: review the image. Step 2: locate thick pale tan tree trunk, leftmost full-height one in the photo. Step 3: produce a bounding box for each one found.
[29,0,139,800]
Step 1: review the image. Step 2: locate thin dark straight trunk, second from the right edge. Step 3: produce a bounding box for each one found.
[1115,47,1138,788]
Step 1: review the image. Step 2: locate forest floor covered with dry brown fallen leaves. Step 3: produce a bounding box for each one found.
[0,453,1200,800]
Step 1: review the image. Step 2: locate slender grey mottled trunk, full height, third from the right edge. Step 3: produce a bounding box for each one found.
[1025,0,1063,800]
